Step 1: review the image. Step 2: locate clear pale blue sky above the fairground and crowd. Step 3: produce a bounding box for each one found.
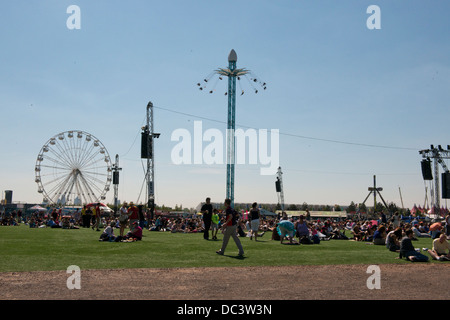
[0,0,450,208]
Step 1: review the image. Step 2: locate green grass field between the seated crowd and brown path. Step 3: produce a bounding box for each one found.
[0,225,435,272]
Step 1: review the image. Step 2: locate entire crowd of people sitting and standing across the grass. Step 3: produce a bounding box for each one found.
[0,198,450,261]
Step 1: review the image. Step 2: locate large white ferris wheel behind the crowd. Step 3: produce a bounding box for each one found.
[35,130,112,205]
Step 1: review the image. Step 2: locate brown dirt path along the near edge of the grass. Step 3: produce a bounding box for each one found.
[0,262,450,300]
